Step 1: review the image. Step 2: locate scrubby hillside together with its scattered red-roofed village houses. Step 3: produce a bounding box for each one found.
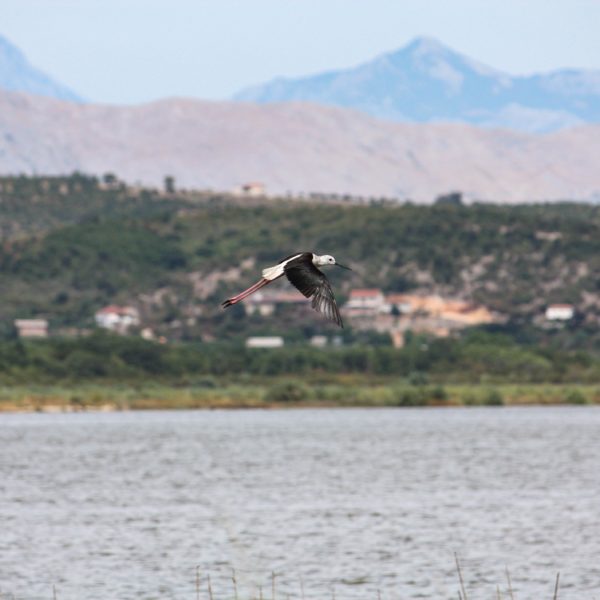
[0,174,600,347]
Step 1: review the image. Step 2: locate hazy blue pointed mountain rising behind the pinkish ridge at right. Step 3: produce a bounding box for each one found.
[234,38,600,132]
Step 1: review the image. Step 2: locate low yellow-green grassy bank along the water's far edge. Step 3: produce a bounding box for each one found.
[0,377,600,412]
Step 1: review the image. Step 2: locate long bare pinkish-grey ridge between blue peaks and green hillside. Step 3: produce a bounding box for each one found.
[0,91,600,202]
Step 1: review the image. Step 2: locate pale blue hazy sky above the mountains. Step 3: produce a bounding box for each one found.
[0,0,600,103]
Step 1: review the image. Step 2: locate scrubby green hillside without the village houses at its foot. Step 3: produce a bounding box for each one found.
[0,175,600,344]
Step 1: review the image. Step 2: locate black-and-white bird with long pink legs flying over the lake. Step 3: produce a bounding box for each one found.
[221,252,352,327]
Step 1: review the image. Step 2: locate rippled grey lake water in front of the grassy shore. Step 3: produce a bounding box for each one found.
[0,407,600,600]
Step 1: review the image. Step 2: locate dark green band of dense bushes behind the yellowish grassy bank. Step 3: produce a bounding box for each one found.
[0,329,600,385]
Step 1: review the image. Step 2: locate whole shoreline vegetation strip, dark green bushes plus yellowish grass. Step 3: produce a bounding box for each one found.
[0,330,600,410]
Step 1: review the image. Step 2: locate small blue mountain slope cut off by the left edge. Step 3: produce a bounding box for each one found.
[0,36,81,102]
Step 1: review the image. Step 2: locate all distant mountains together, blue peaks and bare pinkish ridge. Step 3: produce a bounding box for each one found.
[0,32,600,202]
